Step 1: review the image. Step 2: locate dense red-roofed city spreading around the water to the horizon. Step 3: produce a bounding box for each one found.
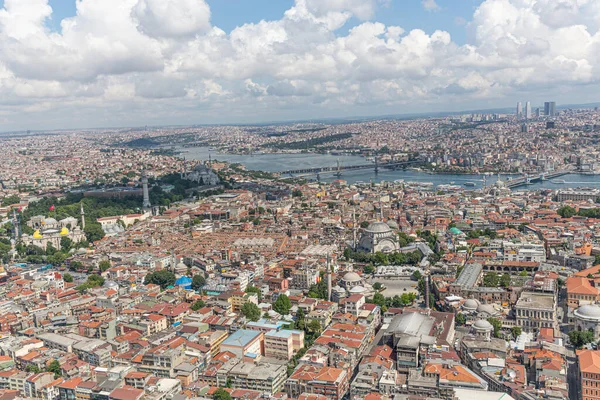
[0,102,600,400]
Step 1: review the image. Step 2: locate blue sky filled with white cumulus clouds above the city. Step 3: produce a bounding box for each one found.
[0,0,600,131]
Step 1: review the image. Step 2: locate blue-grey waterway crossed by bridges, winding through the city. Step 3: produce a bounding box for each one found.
[179,147,600,190]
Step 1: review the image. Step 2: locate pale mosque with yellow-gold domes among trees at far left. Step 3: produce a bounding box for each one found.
[21,209,85,250]
